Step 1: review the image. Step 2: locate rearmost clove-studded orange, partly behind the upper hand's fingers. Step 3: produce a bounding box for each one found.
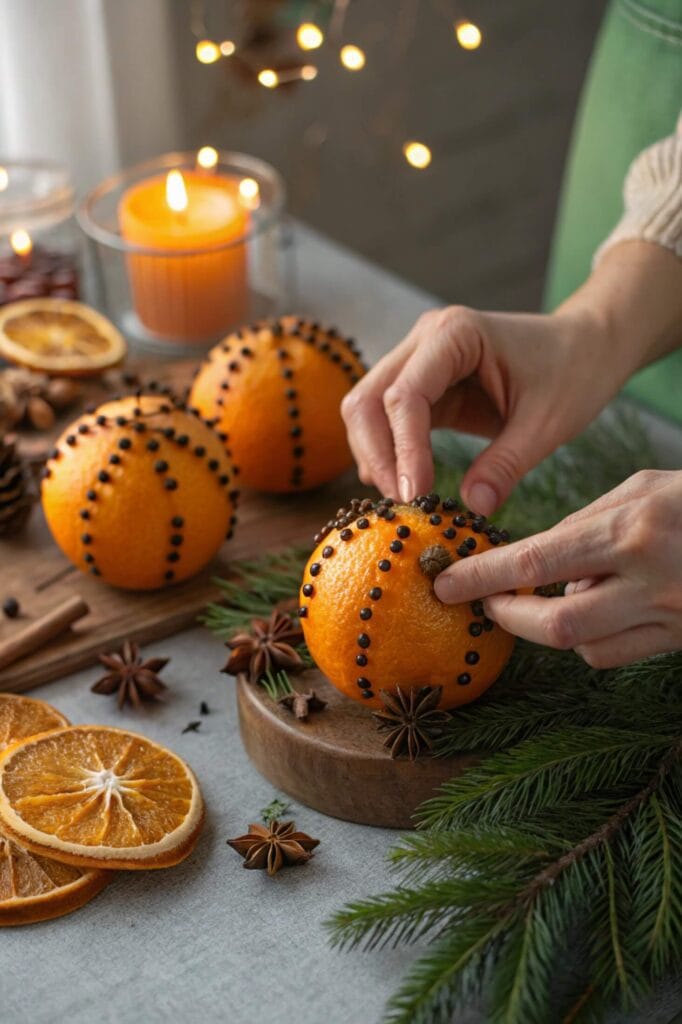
[188,316,365,493]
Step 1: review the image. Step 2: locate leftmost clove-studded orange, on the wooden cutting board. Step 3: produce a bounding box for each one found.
[42,394,238,590]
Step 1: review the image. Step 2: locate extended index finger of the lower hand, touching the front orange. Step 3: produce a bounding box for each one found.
[434,516,615,604]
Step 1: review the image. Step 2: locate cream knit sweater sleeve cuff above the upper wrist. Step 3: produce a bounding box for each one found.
[593,115,682,265]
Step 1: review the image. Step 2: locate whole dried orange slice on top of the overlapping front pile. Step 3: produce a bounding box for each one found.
[0,725,204,868]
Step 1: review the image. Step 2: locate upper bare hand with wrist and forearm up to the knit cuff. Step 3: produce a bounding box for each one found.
[342,241,682,515]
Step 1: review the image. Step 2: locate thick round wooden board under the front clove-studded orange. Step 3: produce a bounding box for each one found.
[237,670,476,828]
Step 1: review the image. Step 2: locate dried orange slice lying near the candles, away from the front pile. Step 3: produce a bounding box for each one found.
[0,298,126,377]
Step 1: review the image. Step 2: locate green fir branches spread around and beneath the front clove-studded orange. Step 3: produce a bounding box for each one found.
[199,408,682,1024]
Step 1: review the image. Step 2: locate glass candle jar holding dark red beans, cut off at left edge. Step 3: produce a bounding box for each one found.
[0,157,81,305]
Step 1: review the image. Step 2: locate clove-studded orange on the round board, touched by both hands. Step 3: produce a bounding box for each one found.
[299,495,514,709]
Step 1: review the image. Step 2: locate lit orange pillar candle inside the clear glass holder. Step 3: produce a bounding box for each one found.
[119,171,249,341]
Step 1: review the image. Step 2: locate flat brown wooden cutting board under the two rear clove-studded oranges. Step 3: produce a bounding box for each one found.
[0,361,363,691]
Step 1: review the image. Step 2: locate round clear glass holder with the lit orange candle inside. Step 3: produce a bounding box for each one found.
[78,148,288,352]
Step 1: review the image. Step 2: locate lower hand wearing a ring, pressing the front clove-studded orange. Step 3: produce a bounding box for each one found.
[434,470,682,669]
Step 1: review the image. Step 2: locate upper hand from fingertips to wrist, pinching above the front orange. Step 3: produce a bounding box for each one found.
[342,306,631,515]
